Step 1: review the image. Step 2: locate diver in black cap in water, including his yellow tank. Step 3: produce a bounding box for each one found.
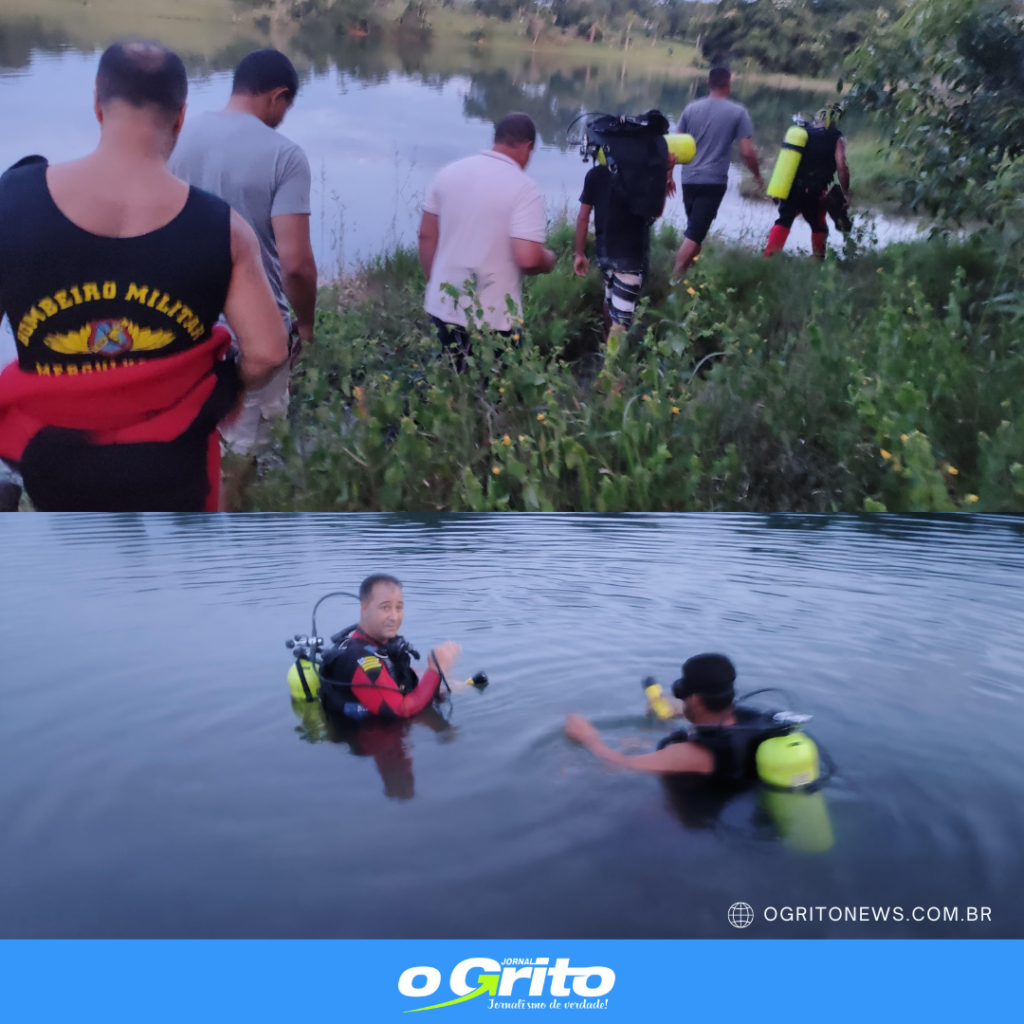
[565,654,833,852]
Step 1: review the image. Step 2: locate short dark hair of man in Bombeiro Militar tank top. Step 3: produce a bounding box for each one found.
[96,39,188,117]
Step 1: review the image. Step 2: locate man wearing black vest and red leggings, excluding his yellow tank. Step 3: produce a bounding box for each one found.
[765,103,850,258]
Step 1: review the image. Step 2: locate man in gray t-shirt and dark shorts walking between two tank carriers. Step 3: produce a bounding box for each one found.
[672,68,764,278]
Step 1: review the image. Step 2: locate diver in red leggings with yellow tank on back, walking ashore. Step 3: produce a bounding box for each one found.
[765,103,853,258]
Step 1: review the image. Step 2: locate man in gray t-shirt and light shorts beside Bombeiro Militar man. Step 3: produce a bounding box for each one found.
[169,49,316,454]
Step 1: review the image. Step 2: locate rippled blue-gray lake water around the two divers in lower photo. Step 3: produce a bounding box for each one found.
[0,515,1024,938]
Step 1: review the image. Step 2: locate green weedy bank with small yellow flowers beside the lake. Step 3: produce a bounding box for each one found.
[243,225,1024,514]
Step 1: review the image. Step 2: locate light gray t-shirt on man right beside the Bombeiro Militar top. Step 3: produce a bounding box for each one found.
[169,111,310,317]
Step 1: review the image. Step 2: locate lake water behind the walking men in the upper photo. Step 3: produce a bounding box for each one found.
[0,14,915,276]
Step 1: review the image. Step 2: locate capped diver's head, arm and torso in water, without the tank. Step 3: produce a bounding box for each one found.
[565,654,791,781]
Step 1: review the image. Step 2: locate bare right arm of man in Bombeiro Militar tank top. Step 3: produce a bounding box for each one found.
[224,210,288,388]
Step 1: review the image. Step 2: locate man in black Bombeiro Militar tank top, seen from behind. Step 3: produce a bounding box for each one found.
[0,42,287,512]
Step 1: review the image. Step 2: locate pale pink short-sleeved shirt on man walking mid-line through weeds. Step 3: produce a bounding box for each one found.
[424,151,547,331]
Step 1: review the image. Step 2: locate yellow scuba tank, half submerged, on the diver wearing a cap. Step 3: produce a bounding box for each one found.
[756,732,836,853]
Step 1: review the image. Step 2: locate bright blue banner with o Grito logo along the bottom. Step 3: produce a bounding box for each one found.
[0,939,1024,1024]
